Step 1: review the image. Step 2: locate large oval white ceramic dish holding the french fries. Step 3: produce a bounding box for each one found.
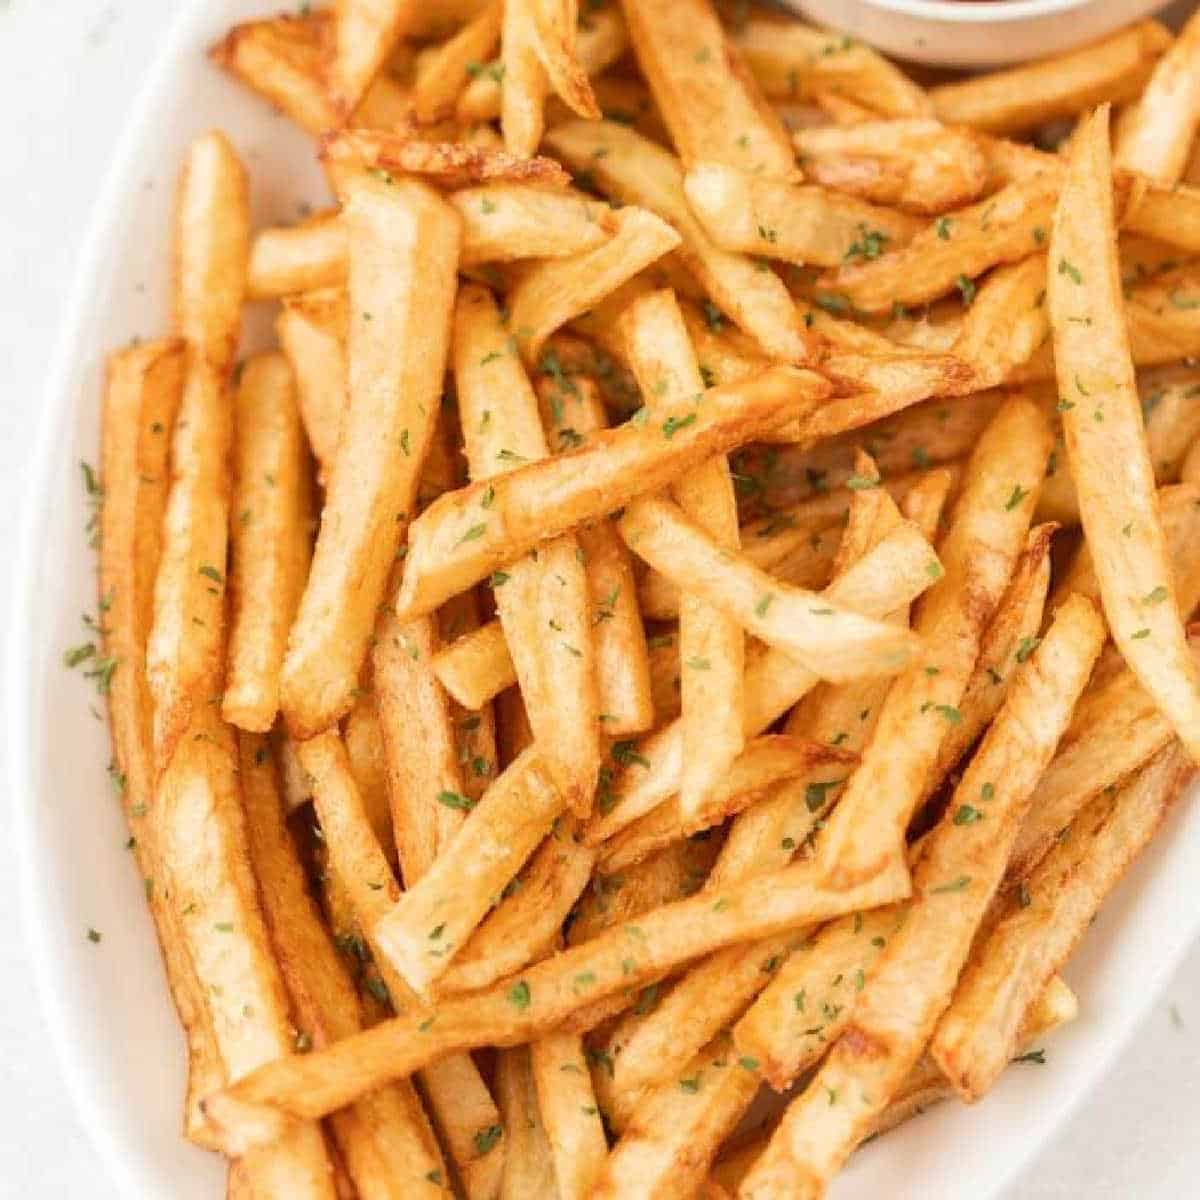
[8,0,1200,1200]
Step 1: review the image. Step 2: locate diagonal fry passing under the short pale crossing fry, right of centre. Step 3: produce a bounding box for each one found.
[584,524,941,845]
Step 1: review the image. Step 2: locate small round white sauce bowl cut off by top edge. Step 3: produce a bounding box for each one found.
[784,0,1168,67]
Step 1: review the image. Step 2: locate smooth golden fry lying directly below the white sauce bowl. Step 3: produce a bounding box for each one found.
[929,20,1171,134]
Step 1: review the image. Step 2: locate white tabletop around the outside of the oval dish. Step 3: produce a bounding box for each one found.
[0,0,1200,1200]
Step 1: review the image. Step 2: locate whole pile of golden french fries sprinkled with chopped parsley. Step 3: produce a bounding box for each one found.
[91,0,1200,1200]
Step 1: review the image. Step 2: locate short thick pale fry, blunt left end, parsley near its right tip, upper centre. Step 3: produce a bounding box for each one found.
[684,162,923,266]
